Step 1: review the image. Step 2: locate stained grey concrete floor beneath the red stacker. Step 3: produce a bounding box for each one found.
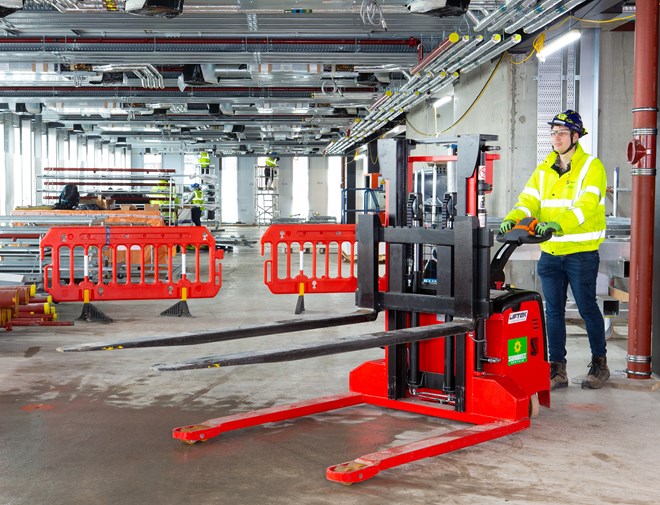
[0,228,660,505]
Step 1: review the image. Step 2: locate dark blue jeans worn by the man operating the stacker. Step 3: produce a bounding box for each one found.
[538,251,607,363]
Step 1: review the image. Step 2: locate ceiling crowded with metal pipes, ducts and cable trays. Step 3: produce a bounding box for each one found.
[0,0,634,156]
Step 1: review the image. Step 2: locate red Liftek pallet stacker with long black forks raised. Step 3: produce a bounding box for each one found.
[61,135,550,484]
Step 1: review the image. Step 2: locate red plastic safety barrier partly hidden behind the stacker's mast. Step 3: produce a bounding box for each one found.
[261,224,366,294]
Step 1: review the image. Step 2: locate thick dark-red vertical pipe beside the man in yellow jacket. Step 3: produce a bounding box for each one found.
[626,0,658,379]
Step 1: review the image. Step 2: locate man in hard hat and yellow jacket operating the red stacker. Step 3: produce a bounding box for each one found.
[500,110,610,389]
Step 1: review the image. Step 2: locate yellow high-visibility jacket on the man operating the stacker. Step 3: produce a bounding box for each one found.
[504,143,607,256]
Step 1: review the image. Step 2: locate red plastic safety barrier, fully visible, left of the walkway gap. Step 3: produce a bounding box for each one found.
[41,226,223,302]
